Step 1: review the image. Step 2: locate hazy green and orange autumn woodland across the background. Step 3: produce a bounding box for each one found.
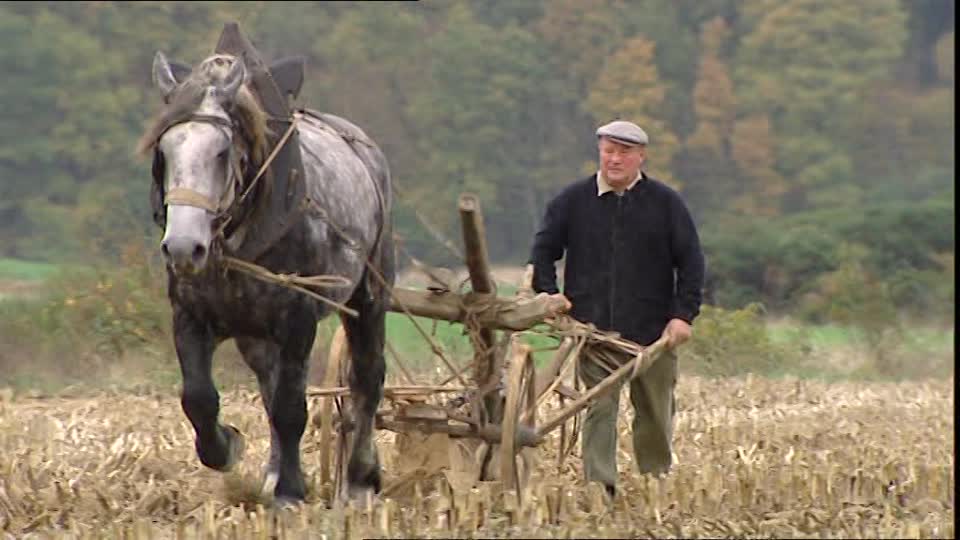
[0,0,955,318]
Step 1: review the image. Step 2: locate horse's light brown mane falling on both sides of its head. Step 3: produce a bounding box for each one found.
[137,54,270,167]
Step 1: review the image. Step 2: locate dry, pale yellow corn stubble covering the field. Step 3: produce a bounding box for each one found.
[0,377,955,539]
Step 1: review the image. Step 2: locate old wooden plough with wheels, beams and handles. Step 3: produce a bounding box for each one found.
[307,194,667,502]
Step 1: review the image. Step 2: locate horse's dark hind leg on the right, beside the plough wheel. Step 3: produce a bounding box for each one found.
[343,286,386,494]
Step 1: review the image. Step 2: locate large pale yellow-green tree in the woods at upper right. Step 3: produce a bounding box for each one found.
[736,0,906,209]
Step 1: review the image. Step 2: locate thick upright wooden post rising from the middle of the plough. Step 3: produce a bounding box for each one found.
[458,193,502,424]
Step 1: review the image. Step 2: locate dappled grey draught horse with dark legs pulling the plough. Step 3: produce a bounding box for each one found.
[140,53,394,501]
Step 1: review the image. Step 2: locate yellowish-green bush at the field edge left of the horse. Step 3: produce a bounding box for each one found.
[0,240,174,390]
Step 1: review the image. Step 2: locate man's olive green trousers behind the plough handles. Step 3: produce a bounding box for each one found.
[578,345,677,488]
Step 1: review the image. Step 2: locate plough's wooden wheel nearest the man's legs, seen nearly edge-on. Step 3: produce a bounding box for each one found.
[500,338,537,496]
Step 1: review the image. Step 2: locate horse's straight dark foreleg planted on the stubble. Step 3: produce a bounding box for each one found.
[270,304,317,501]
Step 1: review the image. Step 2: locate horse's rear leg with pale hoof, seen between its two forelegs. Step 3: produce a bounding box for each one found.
[236,337,280,492]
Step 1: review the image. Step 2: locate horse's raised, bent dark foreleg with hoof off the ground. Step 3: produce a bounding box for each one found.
[173,308,243,471]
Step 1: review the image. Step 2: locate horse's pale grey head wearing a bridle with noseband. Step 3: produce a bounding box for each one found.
[140,52,266,272]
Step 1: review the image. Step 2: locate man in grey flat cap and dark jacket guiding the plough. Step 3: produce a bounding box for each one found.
[531,120,704,496]
